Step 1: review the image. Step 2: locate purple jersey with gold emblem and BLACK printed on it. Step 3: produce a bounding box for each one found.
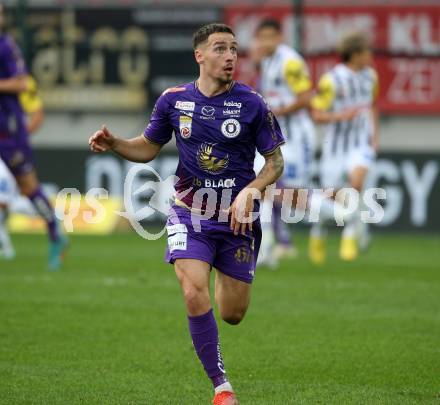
[144,82,284,215]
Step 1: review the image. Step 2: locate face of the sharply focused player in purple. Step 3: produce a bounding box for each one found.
[196,32,237,83]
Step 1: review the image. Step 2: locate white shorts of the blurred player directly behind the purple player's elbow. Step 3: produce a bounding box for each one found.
[254,125,315,188]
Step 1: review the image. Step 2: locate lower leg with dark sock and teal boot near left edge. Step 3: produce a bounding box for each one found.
[16,170,67,270]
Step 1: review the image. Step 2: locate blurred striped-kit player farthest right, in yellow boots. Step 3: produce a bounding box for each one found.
[309,33,379,263]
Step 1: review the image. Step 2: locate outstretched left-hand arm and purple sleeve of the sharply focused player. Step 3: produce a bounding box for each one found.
[89,93,173,163]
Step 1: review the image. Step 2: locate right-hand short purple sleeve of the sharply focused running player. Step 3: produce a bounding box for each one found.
[255,96,284,155]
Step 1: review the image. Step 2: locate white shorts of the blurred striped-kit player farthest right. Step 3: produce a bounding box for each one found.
[320,146,376,188]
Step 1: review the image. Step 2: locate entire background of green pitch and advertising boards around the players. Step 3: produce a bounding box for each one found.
[0,0,440,405]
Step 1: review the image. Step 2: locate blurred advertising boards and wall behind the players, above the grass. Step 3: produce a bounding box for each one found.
[5,0,440,231]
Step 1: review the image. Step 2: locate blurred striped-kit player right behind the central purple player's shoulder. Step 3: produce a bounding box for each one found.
[254,19,315,266]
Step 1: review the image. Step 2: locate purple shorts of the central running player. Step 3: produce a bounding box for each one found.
[165,206,261,284]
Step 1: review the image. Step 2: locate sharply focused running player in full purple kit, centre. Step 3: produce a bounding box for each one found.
[89,24,284,405]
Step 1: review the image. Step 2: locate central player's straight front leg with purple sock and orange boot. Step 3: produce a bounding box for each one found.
[174,259,238,405]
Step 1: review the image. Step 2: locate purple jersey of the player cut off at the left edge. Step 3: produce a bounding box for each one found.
[0,35,27,141]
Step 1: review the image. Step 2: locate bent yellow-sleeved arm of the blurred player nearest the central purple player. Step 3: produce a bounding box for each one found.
[273,59,313,117]
